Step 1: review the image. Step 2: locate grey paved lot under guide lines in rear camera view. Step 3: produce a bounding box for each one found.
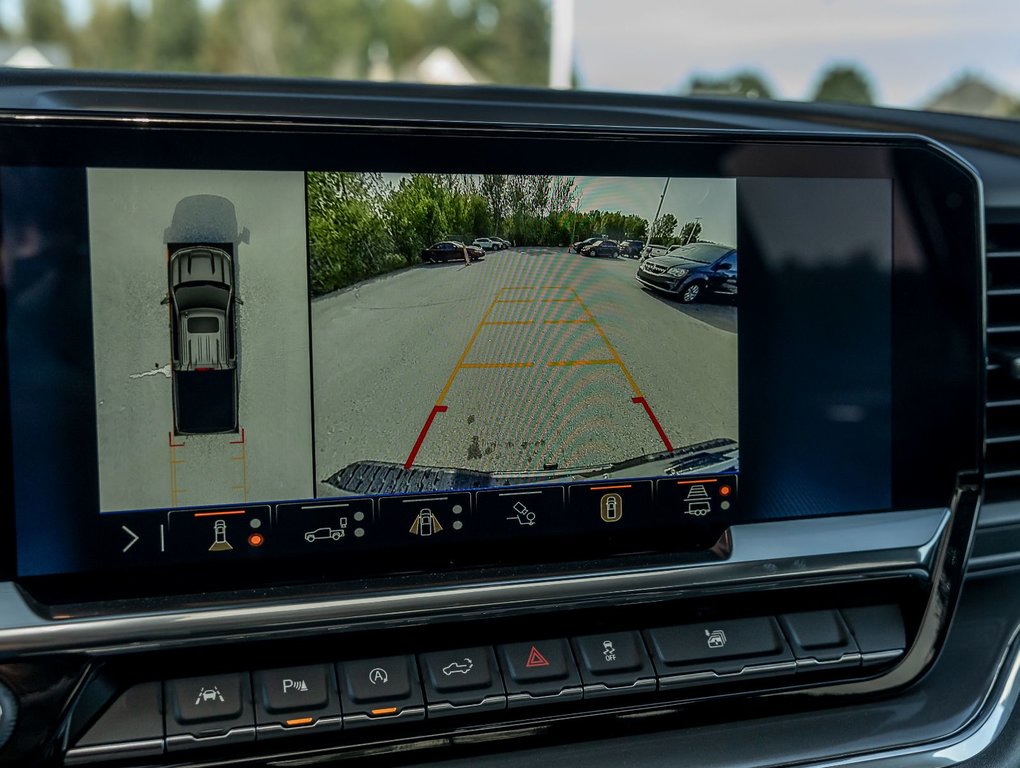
[312,248,737,495]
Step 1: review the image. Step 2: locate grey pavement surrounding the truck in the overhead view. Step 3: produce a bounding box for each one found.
[89,169,314,511]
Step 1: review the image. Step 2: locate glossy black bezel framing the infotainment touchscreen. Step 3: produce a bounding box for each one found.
[0,116,984,602]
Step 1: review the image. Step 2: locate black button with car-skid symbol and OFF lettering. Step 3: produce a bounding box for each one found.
[572,632,656,697]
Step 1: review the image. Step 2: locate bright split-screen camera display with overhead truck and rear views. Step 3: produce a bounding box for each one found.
[88,169,737,516]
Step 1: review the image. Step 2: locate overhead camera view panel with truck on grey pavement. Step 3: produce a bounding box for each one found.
[88,168,312,512]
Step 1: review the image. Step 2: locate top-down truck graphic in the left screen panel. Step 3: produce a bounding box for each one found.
[163,195,248,434]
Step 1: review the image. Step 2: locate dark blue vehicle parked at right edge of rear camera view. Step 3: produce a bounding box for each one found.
[635,243,736,304]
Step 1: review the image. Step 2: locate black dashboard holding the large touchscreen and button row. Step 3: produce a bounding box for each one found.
[0,68,1020,766]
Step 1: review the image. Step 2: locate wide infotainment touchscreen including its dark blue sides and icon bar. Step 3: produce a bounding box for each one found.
[0,124,979,588]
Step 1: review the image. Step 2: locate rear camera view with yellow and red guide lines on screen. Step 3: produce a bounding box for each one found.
[307,172,737,497]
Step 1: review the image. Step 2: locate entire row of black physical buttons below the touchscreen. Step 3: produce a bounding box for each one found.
[77,606,905,759]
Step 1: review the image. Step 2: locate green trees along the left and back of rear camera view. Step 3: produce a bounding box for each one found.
[308,171,656,296]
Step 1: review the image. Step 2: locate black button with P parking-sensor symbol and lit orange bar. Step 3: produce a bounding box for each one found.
[252,664,341,738]
